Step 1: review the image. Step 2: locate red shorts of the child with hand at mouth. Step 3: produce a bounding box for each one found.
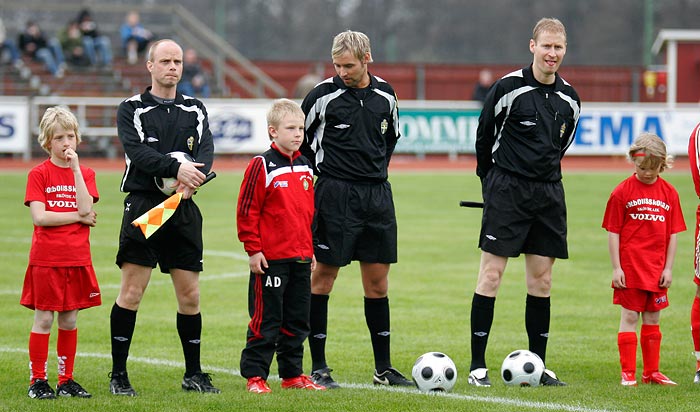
[19,265,102,312]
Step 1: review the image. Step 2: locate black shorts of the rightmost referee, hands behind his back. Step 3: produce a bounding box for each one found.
[479,167,569,259]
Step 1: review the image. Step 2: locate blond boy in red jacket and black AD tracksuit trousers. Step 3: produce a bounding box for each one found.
[236,99,326,393]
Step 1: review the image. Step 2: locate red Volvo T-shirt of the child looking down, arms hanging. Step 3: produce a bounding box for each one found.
[603,175,686,292]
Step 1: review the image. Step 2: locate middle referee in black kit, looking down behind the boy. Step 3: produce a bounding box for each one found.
[301,30,413,389]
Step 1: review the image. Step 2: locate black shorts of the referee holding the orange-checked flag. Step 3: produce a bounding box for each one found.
[116,192,203,273]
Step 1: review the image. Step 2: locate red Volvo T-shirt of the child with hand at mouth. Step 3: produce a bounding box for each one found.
[24,159,99,267]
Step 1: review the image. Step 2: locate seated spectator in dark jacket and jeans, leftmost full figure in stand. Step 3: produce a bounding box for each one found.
[19,20,65,78]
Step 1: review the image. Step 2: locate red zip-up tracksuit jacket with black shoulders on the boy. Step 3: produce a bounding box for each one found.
[236,143,314,262]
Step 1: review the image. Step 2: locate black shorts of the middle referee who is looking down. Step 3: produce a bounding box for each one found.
[313,177,397,267]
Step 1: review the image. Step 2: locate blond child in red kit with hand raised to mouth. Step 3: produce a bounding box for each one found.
[20,107,102,399]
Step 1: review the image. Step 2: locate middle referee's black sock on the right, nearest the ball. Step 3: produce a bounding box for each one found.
[365,297,391,373]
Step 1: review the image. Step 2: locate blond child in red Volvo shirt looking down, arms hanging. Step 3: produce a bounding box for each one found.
[603,133,686,386]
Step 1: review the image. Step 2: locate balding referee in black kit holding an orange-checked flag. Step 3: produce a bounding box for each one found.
[109,39,219,396]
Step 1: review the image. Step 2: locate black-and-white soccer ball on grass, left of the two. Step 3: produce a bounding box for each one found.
[411,352,457,392]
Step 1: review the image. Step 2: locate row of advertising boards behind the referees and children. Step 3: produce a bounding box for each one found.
[0,96,700,159]
